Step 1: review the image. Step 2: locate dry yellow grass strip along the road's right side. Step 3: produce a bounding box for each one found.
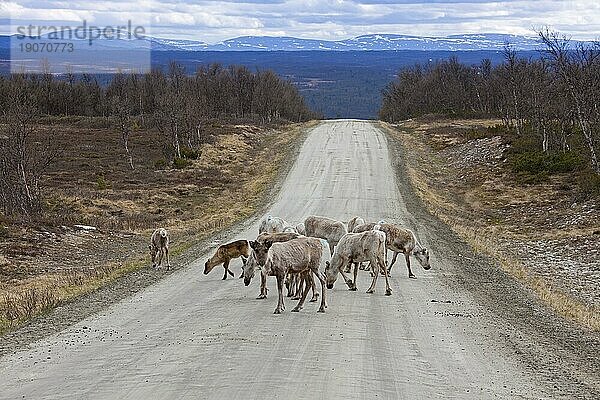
[384,122,600,332]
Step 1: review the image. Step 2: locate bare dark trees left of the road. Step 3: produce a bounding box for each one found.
[0,63,317,216]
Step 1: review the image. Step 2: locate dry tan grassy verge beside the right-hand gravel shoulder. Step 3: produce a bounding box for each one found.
[382,124,600,331]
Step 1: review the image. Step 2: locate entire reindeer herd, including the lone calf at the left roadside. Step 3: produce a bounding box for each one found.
[150,216,431,314]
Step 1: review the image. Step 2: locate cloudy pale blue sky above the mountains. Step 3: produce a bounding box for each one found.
[0,0,600,43]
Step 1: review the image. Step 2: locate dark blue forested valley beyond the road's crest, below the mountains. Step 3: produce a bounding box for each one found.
[153,51,539,119]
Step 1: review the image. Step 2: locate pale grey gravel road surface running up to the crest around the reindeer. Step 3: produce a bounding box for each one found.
[0,120,600,400]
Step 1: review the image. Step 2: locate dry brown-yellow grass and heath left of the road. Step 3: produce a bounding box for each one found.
[0,119,314,334]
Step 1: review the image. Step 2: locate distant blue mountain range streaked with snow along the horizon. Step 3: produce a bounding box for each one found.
[0,33,575,51]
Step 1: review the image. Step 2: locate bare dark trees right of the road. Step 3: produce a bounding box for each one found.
[379,30,600,180]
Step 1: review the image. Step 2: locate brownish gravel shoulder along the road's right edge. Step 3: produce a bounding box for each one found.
[374,121,600,399]
